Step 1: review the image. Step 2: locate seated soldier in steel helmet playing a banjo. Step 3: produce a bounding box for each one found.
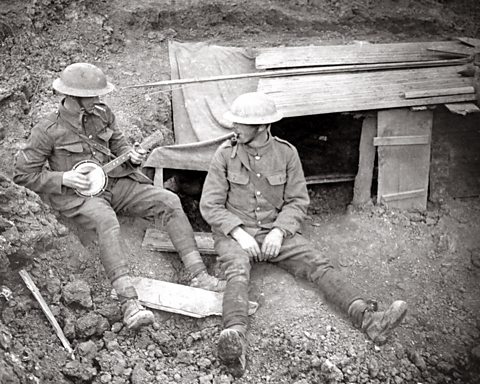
[14,63,224,329]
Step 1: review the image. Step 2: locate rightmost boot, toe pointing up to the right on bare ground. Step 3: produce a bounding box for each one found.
[348,300,407,345]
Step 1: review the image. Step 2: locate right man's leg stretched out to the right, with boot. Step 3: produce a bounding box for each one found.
[271,234,407,344]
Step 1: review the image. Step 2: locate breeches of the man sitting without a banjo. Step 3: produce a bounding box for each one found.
[215,231,361,329]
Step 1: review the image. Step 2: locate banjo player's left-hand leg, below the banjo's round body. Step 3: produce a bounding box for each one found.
[62,197,154,329]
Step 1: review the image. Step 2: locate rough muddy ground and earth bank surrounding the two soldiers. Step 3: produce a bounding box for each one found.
[0,0,480,384]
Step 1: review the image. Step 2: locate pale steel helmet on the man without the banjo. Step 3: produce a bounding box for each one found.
[224,92,283,125]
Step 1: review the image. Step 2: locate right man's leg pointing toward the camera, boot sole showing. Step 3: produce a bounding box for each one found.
[215,236,251,377]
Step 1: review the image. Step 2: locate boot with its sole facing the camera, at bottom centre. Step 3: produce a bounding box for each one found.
[217,328,247,377]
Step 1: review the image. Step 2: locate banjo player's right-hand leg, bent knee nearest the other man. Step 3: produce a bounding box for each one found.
[111,178,225,291]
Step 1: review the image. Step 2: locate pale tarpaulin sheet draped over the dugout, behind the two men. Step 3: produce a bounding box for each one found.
[145,42,258,170]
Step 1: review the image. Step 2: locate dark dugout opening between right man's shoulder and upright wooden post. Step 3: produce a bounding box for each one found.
[272,113,363,213]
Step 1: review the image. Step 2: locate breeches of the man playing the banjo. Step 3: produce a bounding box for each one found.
[62,178,197,282]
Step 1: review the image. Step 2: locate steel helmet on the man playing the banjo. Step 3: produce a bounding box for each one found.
[53,63,114,97]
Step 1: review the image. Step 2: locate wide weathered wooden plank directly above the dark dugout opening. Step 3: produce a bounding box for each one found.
[258,66,476,117]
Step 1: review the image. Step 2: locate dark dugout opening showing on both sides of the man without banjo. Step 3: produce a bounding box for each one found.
[164,113,363,231]
